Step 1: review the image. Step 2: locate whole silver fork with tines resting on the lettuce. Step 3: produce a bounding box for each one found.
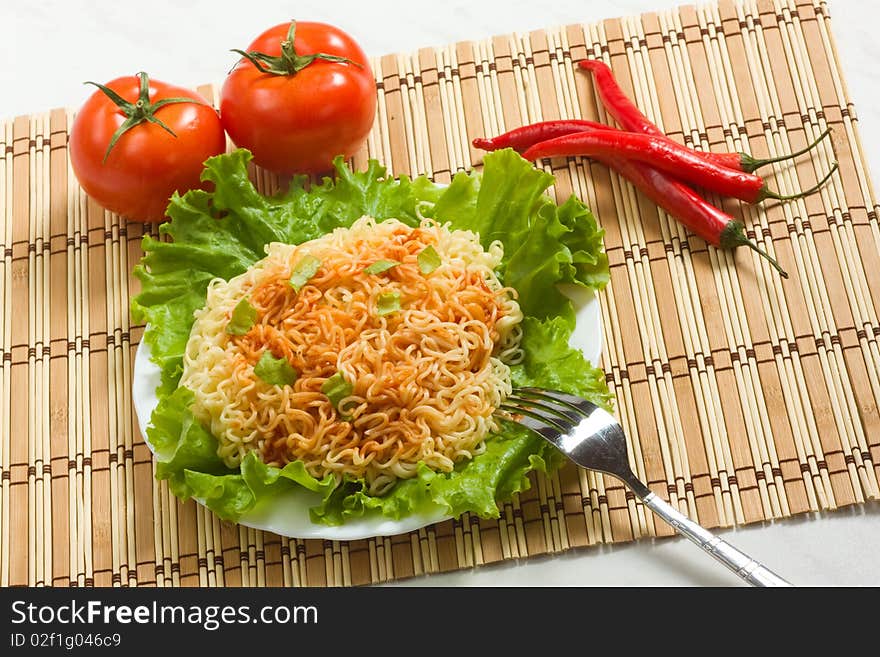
[501,388,791,586]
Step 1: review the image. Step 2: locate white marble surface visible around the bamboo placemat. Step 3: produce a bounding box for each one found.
[0,0,880,586]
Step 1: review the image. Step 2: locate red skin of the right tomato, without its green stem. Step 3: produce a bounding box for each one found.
[220,21,376,174]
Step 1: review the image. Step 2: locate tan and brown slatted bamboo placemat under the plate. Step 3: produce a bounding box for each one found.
[0,0,880,586]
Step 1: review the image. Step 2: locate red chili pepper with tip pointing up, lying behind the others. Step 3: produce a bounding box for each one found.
[578,59,831,173]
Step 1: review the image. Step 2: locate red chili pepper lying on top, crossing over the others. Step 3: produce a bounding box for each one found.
[523,130,837,203]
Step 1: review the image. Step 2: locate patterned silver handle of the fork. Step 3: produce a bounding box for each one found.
[642,492,791,586]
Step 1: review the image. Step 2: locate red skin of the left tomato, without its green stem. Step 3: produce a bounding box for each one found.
[68,76,226,222]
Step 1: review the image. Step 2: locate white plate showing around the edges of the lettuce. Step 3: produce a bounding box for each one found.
[132,286,602,541]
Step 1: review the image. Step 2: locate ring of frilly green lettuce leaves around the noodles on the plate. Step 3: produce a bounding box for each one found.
[131,150,611,524]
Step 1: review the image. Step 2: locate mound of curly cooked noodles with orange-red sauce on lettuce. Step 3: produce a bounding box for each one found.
[180,217,522,494]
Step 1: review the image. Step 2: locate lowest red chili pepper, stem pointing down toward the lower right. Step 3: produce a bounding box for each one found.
[597,157,788,278]
